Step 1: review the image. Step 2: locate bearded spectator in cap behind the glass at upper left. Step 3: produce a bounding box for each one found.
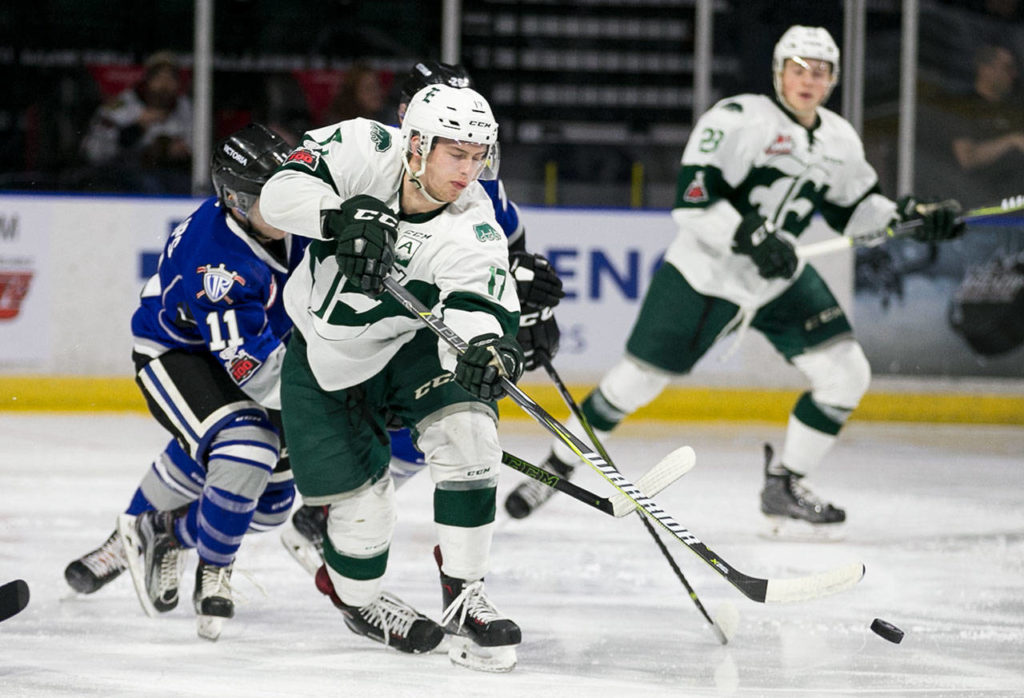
[82,51,193,193]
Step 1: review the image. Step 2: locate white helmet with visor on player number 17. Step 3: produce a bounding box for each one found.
[401,85,498,195]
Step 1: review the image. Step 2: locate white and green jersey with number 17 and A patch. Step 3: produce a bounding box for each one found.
[260,119,519,390]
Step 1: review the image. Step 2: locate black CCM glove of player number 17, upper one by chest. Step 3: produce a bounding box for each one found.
[322,194,398,296]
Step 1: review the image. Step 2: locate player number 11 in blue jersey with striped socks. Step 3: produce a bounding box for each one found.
[65,124,308,640]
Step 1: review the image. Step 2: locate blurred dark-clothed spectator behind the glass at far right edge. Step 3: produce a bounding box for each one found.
[950,44,1024,205]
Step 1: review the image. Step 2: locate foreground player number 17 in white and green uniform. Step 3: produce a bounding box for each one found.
[262,85,523,670]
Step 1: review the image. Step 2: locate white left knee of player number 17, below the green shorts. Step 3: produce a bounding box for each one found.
[327,477,397,558]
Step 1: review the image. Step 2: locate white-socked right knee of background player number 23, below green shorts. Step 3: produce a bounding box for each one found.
[793,340,871,409]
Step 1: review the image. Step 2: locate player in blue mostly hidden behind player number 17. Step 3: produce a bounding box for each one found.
[281,60,565,574]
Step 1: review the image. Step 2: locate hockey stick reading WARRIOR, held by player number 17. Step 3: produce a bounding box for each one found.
[384,276,864,603]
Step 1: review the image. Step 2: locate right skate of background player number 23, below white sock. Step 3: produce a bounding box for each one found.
[761,443,846,540]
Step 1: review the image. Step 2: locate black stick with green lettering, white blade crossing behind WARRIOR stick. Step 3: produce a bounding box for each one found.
[502,446,696,518]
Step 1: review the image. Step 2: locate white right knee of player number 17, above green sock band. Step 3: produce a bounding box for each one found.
[418,403,502,484]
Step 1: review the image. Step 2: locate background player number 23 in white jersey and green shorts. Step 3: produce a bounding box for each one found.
[506,26,963,534]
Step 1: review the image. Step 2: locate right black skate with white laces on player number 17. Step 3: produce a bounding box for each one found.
[434,547,522,671]
